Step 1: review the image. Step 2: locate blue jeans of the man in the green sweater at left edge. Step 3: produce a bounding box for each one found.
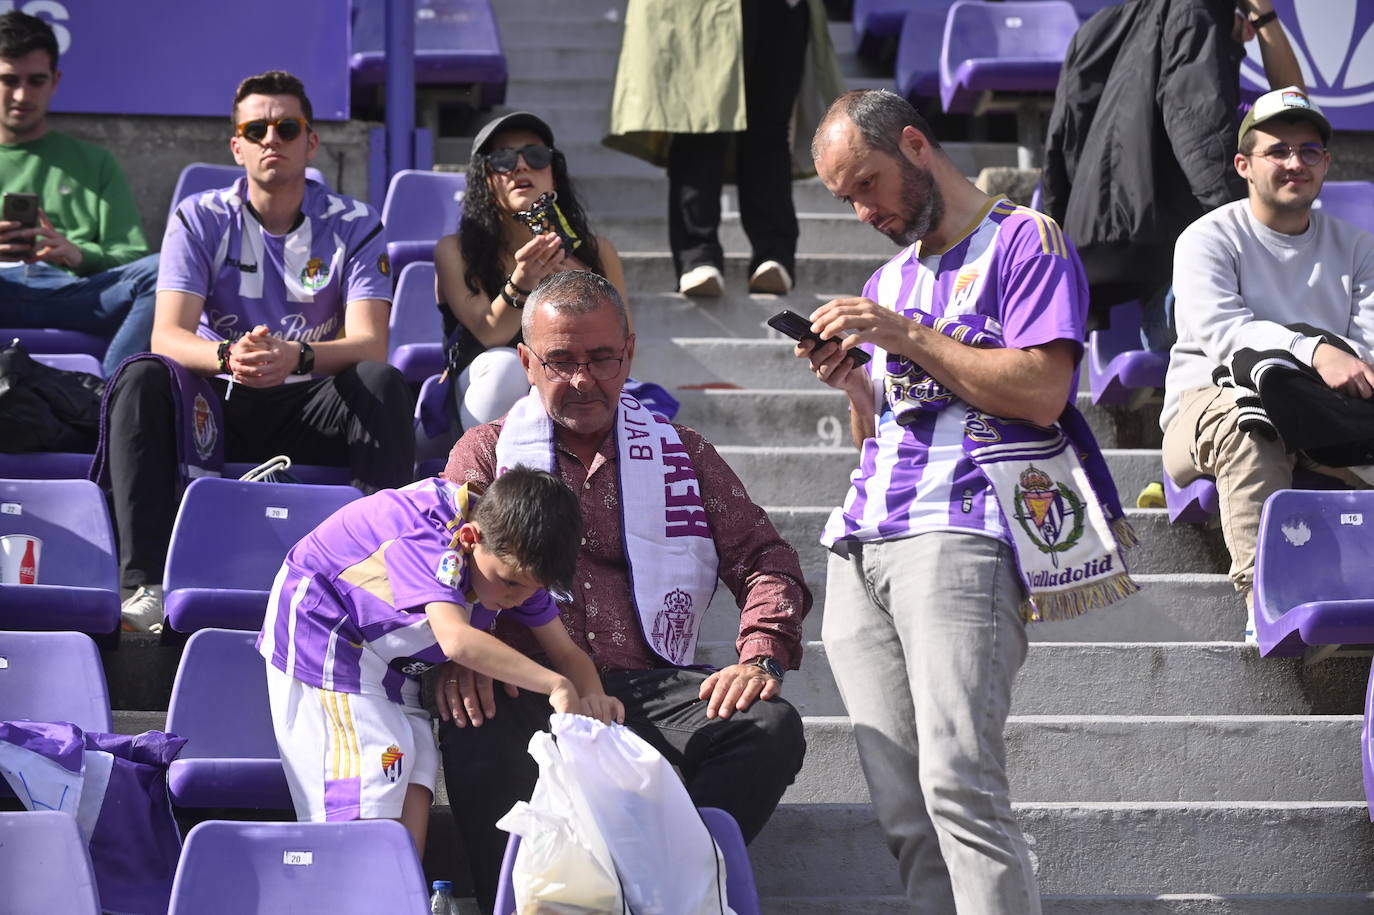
[0,254,158,378]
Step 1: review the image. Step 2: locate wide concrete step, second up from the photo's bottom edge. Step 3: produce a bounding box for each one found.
[749,801,1374,895]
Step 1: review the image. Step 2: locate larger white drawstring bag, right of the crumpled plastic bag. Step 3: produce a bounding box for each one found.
[551,714,734,915]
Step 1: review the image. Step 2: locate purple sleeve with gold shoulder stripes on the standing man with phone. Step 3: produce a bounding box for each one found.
[1000,217,1088,349]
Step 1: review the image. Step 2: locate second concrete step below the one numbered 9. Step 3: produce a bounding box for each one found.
[765,503,1228,581]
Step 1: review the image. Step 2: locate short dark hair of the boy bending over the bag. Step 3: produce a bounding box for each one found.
[473,466,583,591]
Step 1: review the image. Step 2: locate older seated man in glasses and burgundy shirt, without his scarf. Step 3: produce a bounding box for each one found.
[437,265,811,908]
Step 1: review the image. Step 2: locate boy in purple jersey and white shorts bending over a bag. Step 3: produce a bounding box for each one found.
[257,467,625,855]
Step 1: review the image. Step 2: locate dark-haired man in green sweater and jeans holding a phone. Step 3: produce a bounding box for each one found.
[0,12,158,375]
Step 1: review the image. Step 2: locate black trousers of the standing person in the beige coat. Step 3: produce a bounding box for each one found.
[668,0,811,276]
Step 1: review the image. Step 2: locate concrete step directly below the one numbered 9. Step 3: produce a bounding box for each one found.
[716,445,1160,506]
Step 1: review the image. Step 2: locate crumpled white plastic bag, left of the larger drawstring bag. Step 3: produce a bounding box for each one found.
[496,731,628,915]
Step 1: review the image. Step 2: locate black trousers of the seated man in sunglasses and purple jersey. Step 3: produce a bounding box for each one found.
[109,359,415,588]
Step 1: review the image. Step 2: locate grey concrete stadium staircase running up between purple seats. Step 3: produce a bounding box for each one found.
[110,0,1374,915]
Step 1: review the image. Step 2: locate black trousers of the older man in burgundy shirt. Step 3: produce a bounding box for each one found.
[438,668,807,912]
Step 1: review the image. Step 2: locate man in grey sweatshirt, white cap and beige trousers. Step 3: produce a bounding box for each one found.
[1161,87,1374,629]
